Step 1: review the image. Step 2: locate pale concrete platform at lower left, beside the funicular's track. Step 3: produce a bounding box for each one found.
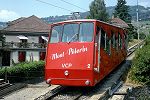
[3,82,57,100]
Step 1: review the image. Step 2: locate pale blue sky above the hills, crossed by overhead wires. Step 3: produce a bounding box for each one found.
[0,0,150,22]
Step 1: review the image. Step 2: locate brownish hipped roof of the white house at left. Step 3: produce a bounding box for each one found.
[4,15,49,33]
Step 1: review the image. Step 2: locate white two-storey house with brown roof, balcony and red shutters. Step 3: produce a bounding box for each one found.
[1,15,49,66]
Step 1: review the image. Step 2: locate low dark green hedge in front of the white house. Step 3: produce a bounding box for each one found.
[0,61,44,82]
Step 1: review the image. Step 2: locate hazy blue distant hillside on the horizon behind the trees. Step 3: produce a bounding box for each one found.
[42,6,150,23]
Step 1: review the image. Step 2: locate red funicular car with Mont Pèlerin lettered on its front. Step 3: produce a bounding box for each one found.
[45,19,127,86]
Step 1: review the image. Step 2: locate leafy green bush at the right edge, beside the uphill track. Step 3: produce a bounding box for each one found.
[129,45,150,84]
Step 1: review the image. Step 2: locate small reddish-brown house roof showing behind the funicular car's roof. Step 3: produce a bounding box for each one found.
[110,18,129,28]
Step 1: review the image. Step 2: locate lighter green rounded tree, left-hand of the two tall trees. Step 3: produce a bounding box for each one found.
[88,0,109,21]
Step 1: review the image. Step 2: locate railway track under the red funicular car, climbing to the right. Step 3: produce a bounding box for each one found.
[1,41,144,100]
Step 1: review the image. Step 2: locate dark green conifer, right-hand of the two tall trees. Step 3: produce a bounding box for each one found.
[114,0,132,23]
